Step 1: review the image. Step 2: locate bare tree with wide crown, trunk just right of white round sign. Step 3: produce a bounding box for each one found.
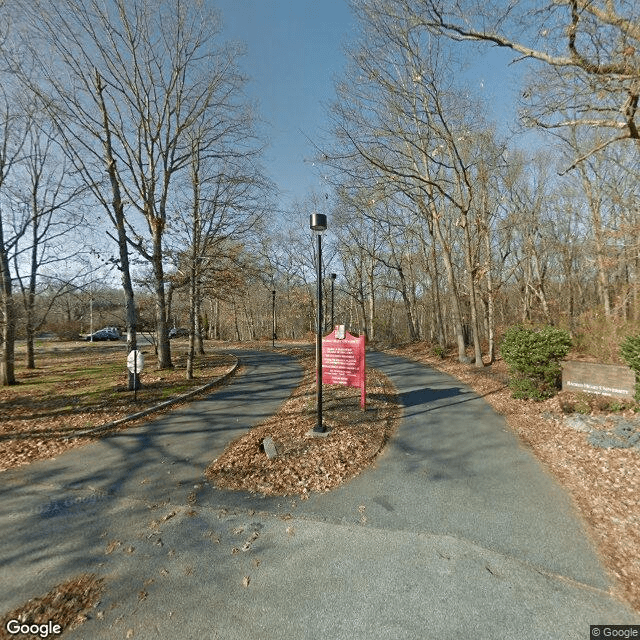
[24,0,250,368]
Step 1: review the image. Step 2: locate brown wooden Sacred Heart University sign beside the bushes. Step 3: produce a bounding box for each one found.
[562,360,636,400]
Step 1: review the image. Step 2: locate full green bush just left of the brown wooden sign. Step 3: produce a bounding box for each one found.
[500,325,571,400]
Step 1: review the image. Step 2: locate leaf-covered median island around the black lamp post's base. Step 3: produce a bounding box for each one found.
[206,350,401,499]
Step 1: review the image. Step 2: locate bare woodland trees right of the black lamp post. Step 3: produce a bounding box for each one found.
[322,0,640,366]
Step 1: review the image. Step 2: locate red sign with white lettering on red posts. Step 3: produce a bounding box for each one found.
[322,327,366,409]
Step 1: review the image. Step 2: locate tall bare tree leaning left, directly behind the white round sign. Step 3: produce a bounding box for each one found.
[15,2,139,390]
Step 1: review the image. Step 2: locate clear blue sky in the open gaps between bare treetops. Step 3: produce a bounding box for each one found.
[212,0,518,215]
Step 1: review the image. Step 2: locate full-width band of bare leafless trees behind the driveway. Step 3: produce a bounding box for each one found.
[0,0,640,385]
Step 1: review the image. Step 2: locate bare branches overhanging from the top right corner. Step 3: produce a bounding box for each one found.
[364,0,640,166]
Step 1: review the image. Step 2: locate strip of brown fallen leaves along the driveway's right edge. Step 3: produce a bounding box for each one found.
[393,344,640,611]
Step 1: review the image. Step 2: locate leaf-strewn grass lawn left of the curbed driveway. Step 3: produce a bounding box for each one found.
[0,341,235,471]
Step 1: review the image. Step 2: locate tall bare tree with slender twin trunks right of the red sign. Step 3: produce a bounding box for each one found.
[330,4,490,366]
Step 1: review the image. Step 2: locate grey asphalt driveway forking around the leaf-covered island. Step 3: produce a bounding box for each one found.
[0,352,640,640]
